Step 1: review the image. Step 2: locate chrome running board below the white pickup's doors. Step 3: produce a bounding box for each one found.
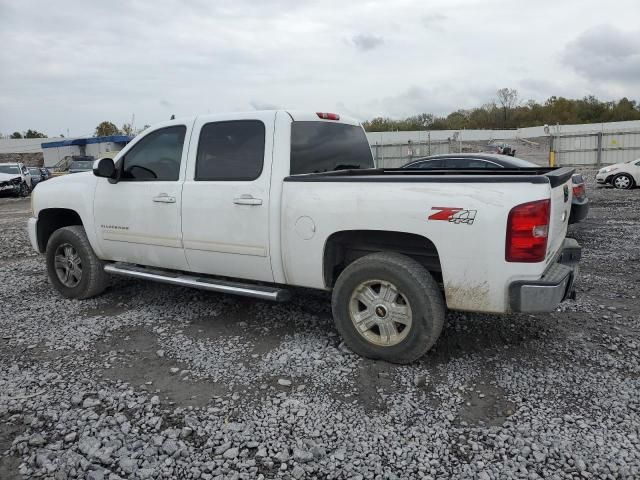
[104,263,291,302]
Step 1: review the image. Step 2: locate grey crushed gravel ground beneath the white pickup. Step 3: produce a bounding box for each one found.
[0,171,640,480]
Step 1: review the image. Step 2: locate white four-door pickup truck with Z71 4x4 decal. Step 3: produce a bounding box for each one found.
[28,111,580,363]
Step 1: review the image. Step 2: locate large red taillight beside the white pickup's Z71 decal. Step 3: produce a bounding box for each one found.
[505,199,551,263]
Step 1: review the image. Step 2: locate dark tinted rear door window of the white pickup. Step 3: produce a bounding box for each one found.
[195,120,265,181]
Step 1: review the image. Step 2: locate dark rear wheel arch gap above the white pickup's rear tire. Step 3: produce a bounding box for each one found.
[322,230,442,288]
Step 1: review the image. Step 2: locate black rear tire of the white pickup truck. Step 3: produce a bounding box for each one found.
[331,252,445,363]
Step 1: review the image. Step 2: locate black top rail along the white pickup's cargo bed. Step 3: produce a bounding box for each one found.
[284,167,575,188]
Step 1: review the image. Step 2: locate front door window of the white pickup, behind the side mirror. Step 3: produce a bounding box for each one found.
[121,125,187,181]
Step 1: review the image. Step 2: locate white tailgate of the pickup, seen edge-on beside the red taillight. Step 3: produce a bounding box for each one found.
[545,167,575,263]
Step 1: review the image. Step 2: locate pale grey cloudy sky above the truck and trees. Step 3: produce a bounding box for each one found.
[0,0,640,136]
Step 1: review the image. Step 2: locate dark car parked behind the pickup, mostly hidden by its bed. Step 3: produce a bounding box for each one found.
[402,153,589,223]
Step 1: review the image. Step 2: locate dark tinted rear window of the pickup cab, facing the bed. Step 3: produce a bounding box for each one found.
[291,122,373,175]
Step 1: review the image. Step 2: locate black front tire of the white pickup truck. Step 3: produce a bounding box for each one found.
[46,225,109,299]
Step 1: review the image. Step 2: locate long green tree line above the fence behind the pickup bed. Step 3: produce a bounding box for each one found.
[363,88,640,132]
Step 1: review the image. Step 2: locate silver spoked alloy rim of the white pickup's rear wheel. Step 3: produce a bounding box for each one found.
[349,280,413,347]
